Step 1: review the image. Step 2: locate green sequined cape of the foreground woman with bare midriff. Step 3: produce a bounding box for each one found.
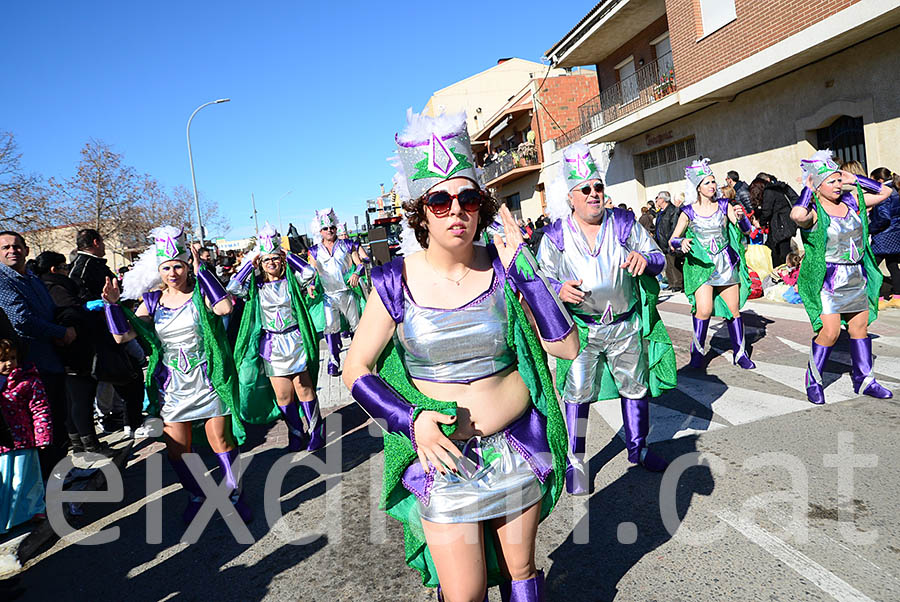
[378,284,568,587]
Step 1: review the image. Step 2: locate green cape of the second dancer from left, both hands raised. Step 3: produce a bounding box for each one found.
[234,268,319,424]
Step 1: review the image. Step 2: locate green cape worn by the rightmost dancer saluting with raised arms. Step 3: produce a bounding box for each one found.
[797,184,884,332]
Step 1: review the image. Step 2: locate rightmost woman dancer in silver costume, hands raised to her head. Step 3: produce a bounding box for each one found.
[791,150,893,404]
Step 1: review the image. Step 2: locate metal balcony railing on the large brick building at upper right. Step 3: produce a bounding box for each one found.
[554,52,677,149]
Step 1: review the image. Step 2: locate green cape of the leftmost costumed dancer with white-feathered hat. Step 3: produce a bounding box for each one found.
[122,286,246,445]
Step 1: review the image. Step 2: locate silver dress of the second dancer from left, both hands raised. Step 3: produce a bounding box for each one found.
[259,278,307,376]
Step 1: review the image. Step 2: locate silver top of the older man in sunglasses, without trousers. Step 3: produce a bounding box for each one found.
[538,210,660,316]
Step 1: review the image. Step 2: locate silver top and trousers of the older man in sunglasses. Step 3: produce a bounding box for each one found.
[538,210,661,403]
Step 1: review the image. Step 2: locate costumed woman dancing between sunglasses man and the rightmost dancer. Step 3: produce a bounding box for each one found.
[669,159,756,370]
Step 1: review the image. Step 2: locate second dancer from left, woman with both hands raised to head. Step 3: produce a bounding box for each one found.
[227,223,325,451]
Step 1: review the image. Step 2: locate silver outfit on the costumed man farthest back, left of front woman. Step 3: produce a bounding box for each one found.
[313,240,359,334]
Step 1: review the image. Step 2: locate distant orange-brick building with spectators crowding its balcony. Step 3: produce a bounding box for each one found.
[472,69,597,219]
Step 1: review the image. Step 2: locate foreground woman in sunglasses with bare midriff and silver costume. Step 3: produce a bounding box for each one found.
[343,114,578,601]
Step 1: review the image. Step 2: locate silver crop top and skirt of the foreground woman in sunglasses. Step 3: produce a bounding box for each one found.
[394,264,543,523]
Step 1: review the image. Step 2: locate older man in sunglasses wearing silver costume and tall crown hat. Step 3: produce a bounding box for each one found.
[538,143,675,495]
